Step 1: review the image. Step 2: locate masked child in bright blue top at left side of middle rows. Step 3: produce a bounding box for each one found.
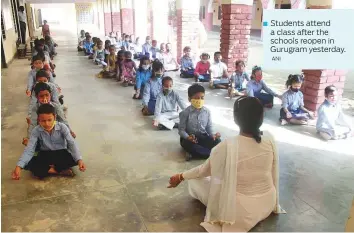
[133,56,151,99]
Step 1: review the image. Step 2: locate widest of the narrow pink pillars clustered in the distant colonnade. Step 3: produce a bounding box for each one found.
[120,0,134,35]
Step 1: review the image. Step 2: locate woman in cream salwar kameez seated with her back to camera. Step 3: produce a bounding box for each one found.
[169,96,285,232]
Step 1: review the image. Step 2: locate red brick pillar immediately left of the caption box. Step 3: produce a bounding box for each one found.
[220,0,253,72]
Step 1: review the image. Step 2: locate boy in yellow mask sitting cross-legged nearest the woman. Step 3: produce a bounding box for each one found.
[179,84,221,161]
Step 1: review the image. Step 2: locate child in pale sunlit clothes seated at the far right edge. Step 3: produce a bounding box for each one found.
[316,86,354,141]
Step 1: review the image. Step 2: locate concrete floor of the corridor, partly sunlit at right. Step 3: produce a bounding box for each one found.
[1,29,354,232]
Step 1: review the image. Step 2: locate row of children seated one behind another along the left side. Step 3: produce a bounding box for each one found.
[12,41,86,180]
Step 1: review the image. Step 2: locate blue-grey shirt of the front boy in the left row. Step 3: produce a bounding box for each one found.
[17,122,82,168]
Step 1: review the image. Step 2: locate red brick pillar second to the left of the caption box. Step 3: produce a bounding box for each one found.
[177,0,199,61]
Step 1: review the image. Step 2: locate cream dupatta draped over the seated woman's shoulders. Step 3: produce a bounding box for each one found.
[204,136,286,225]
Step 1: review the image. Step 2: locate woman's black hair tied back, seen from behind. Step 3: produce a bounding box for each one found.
[234,96,264,143]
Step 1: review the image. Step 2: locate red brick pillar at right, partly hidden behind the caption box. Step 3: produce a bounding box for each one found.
[298,0,347,111]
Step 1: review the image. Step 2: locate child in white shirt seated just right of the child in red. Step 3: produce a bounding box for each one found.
[210,52,230,89]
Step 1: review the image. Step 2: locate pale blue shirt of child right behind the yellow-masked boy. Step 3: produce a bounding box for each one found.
[154,90,186,120]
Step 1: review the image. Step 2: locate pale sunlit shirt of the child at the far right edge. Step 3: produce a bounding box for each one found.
[316,100,352,136]
